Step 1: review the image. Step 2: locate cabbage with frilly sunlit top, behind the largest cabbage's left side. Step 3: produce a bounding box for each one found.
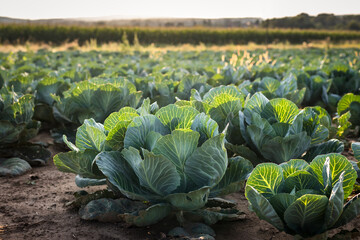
[53,78,141,126]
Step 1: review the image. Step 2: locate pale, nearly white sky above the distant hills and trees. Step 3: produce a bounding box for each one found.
[0,0,360,19]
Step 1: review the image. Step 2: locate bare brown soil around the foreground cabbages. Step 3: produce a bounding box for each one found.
[0,134,360,240]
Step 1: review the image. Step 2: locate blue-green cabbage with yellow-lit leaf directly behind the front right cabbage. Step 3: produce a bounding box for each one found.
[239,93,343,163]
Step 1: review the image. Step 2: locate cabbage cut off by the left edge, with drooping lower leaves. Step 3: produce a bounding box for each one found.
[0,87,50,176]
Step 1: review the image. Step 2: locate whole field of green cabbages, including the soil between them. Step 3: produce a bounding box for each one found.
[0,48,360,239]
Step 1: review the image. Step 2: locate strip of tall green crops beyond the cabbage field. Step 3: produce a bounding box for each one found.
[0,24,360,45]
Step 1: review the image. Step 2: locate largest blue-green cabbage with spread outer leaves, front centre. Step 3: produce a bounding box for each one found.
[96,104,252,215]
